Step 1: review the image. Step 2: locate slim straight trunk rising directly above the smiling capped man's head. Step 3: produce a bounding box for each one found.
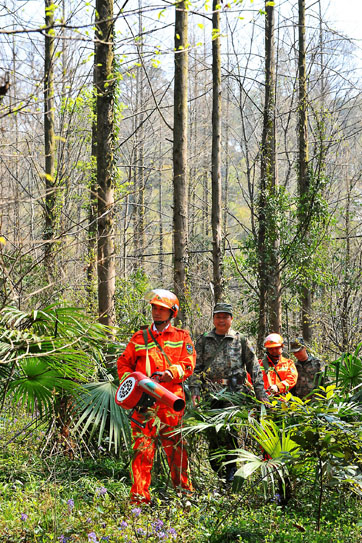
[211,0,222,303]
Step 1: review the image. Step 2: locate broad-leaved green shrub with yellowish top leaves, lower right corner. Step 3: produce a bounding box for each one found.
[289,392,362,530]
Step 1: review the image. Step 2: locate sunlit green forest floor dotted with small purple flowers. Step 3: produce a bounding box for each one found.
[0,417,362,543]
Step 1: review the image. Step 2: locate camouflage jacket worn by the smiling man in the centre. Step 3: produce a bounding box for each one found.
[189,329,266,400]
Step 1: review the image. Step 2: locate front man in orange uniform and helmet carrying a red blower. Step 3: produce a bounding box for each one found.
[117,289,196,503]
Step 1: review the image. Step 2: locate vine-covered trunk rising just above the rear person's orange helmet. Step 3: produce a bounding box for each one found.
[258,5,282,349]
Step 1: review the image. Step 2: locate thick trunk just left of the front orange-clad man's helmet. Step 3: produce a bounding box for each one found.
[95,0,115,325]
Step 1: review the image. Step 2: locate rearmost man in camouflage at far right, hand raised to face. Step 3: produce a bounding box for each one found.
[290,337,324,399]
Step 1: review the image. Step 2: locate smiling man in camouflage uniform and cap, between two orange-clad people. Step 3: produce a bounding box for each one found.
[190,303,267,483]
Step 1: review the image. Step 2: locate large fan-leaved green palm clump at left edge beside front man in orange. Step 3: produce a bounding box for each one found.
[0,305,130,451]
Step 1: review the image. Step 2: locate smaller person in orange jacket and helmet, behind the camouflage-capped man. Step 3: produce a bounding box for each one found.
[248,334,298,396]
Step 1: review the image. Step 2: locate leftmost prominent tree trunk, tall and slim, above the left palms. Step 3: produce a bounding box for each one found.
[44,0,56,278]
